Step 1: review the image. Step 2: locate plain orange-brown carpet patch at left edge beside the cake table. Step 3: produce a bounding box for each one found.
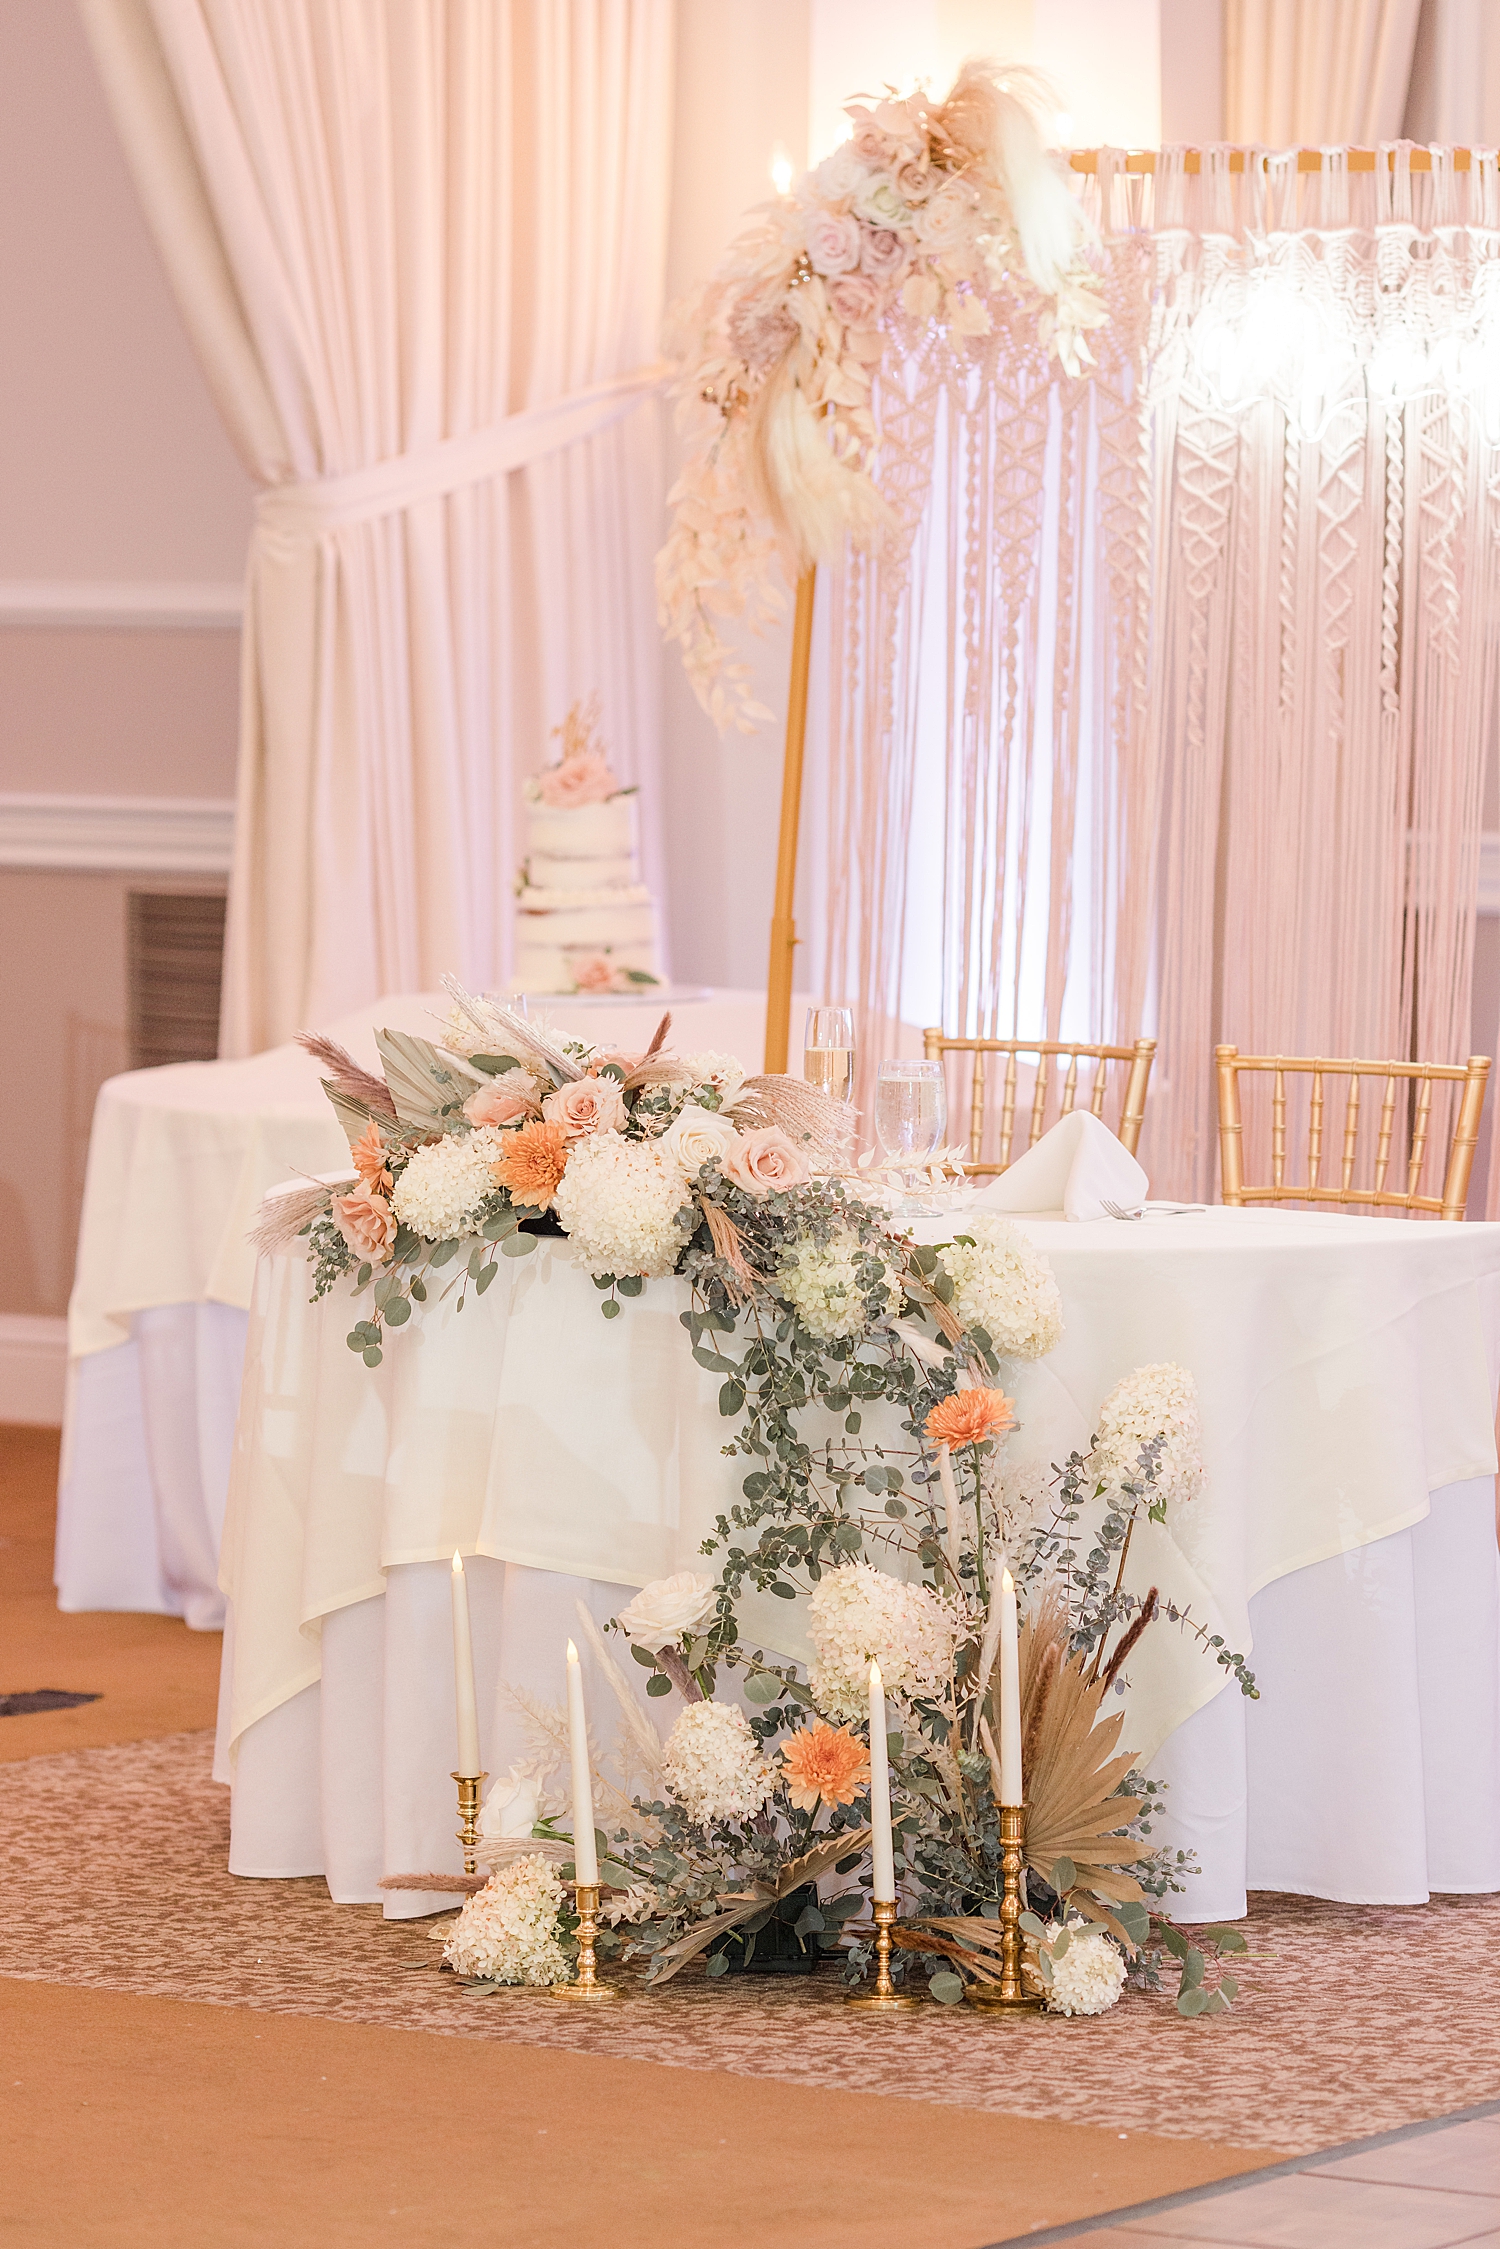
[0,1426,220,1763]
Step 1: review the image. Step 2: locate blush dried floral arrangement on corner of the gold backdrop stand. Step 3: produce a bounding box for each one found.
[657,63,1104,731]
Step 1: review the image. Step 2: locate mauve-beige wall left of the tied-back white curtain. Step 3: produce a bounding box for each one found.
[0,0,250,1313]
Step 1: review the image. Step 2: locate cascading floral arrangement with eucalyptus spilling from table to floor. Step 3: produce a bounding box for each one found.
[261,985,1255,2013]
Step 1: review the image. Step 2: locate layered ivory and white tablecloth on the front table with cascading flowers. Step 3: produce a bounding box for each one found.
[218,1210,1500,1916]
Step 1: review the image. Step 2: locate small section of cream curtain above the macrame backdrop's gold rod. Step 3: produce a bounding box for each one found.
[1223,0,1421,148]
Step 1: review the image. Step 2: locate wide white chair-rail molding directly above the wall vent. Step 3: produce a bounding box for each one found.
[0,794,234,875]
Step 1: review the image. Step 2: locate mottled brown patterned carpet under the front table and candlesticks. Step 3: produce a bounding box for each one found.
[0,1734,1500,2152]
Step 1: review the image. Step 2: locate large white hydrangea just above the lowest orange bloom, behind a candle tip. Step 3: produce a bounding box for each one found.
[807,1561,958,1725]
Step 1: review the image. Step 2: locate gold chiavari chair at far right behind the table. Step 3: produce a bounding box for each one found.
[1214,1046,1489,1219]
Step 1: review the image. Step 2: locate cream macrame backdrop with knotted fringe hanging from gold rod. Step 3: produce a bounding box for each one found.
[825,151,1500,1199]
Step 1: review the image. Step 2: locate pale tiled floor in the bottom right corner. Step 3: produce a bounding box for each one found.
[1043,2116,1500,2249]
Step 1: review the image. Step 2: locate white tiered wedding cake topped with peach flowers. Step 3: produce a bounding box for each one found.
[515,697,661,992]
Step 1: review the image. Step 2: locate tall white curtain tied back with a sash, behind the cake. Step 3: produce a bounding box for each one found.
[81,0,672,1055]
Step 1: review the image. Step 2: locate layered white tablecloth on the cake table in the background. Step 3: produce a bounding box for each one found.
[56,990,805,1631]
